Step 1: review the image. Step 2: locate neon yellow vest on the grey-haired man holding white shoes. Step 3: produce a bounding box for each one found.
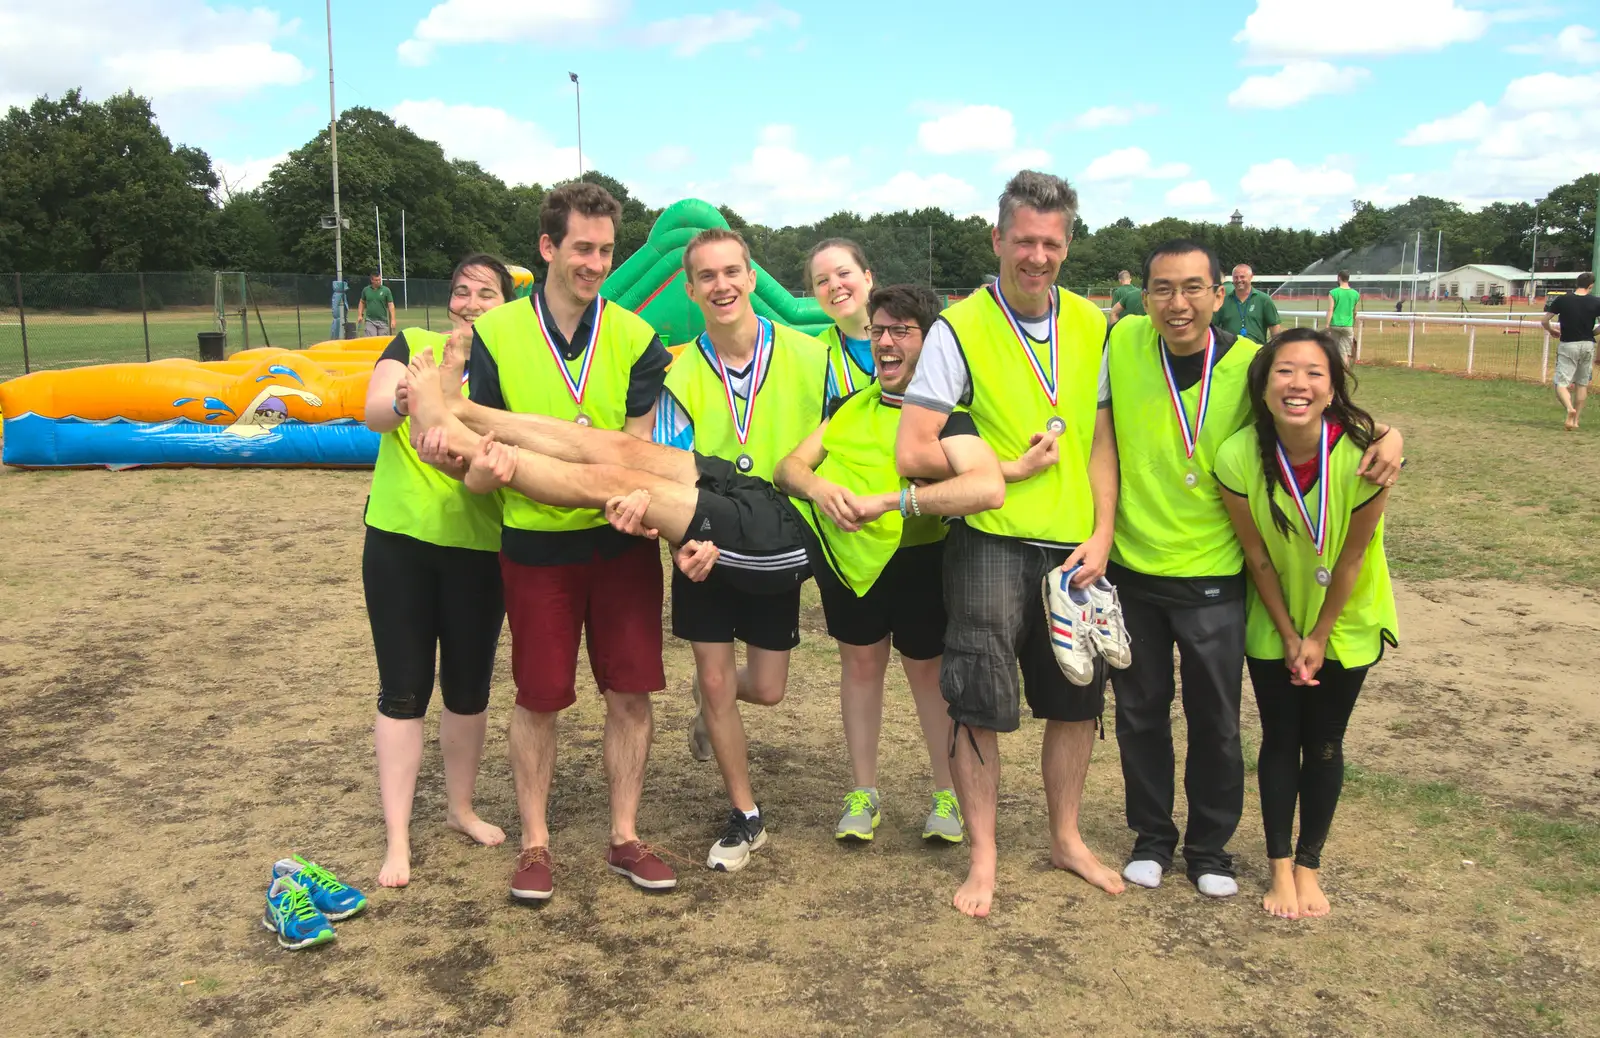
[942,289,1106,544]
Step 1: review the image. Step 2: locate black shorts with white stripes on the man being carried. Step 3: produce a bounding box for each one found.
[688,454,811,591]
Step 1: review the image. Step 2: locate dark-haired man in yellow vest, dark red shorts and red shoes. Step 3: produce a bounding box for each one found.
[469,182,677,900]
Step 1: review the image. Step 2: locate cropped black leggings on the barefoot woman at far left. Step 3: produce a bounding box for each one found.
[362,526,506,720]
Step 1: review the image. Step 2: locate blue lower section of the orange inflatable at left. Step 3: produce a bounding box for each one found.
[0,414,379,469]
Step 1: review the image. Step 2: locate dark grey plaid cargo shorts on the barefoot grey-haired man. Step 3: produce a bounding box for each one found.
[939,521,1106,731]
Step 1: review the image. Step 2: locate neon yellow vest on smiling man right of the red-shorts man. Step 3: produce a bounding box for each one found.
[666,318,827,481]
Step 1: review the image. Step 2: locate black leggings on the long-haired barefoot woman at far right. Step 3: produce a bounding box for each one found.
[1246,659,1368,868]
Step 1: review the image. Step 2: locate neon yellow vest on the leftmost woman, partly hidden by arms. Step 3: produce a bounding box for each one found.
[366,328,501,552]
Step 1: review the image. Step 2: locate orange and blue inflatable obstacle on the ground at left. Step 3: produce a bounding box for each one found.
[0,337,389,469]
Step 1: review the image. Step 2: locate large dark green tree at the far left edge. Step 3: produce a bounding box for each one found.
[0,90,218,272]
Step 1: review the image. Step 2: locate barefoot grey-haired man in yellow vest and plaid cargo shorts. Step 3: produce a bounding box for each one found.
[896,170,1123,916]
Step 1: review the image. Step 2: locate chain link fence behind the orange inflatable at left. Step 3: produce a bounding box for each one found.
[0,270,450,381]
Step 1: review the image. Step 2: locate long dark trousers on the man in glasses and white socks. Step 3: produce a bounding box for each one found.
[1110,590,1245,880]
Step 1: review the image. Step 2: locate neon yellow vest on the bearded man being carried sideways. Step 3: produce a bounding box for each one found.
[790,384,946,597]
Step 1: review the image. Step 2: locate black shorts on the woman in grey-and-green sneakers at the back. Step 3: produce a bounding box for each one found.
[806,534,946,659]
